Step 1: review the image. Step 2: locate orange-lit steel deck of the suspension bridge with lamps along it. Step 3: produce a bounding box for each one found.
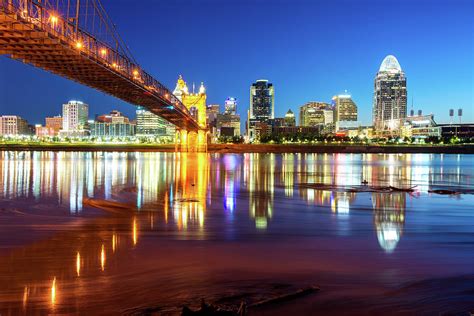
[0,7,202,131]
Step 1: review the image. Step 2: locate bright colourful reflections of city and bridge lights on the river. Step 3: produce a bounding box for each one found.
[0,152,474,312]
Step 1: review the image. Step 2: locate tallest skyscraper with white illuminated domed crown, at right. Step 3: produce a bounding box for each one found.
[373,55,407,131]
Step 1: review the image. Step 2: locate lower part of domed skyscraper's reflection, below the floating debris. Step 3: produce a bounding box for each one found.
[372,192,406,253]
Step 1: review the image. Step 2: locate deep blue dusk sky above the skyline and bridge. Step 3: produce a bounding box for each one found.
[0,0,474,124]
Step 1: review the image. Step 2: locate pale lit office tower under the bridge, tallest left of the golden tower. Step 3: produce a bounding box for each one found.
[61,101,89,136]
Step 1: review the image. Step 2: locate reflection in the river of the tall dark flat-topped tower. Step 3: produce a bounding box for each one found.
[244,154,275,229]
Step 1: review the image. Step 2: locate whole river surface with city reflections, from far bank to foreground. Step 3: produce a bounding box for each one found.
[0,152,474,315]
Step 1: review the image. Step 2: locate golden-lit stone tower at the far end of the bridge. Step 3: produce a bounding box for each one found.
[173,75,207,151]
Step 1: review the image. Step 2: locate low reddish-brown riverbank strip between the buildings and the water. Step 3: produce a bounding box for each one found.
[0,144,474,154]
